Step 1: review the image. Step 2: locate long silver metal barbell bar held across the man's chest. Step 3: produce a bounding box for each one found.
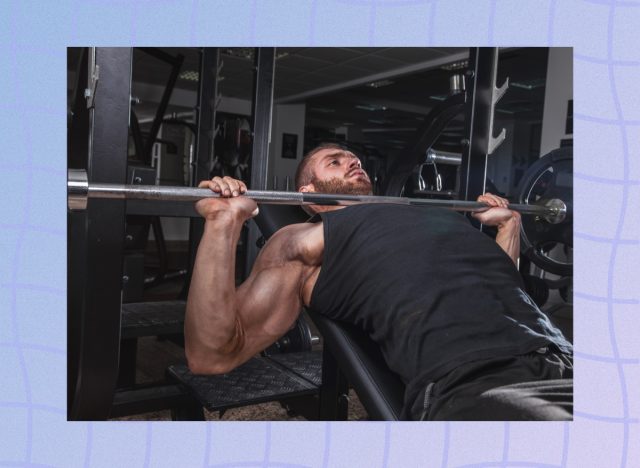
[67,169,567,224]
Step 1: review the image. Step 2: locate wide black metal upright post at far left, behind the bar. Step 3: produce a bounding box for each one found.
[67,47,132,420]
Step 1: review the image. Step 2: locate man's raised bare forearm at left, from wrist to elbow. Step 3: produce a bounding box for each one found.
[185,215,242,368]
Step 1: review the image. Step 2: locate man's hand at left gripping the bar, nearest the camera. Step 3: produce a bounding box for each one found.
[195,177,258,222]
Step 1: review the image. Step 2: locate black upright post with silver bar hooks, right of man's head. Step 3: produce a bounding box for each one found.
[459,47,506,206]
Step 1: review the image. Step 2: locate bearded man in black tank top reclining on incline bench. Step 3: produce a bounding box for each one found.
[185,144,572,420]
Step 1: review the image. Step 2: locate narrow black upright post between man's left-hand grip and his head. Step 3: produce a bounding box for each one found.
[245,47,276,274]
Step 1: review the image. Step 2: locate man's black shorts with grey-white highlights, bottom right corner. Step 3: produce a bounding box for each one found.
[411,347,573,421]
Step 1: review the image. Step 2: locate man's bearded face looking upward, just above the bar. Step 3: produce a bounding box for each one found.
[303,149,371,195]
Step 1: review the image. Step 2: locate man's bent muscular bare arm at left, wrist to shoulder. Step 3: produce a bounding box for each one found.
[185,217,305,374]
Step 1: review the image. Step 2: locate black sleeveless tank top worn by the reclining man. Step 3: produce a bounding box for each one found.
[310,204,571,385]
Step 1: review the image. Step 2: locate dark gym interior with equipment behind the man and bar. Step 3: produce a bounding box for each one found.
[67,47,573,420]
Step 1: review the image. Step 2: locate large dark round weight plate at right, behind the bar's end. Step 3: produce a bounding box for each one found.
[518,147,573,276]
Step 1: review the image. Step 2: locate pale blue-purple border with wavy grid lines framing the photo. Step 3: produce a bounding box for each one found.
[0,0,640,467]
